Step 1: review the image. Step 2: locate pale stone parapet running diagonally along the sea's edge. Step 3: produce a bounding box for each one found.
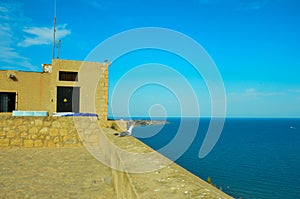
[97,129,232,199]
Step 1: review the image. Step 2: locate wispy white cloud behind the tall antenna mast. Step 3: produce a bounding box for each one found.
[18,24,71,47]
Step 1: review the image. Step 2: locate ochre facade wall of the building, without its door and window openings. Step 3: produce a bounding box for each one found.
[0,59,108,120]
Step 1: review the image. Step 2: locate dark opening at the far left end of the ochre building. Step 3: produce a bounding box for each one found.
[0,92,16,112]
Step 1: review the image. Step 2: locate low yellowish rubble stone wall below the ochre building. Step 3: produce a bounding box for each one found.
[0,116,126,148]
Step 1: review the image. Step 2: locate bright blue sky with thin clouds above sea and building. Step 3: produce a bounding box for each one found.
[0,0,300,117]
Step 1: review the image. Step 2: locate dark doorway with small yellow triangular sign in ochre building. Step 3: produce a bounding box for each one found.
[56,86,80,113]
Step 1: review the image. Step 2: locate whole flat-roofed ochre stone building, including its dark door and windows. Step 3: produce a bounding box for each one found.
[0,59,109,120]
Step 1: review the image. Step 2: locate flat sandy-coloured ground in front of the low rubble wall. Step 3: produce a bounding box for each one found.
[0,147,115,199]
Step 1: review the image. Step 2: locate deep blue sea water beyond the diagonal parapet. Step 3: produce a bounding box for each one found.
[133,118,300,199]
